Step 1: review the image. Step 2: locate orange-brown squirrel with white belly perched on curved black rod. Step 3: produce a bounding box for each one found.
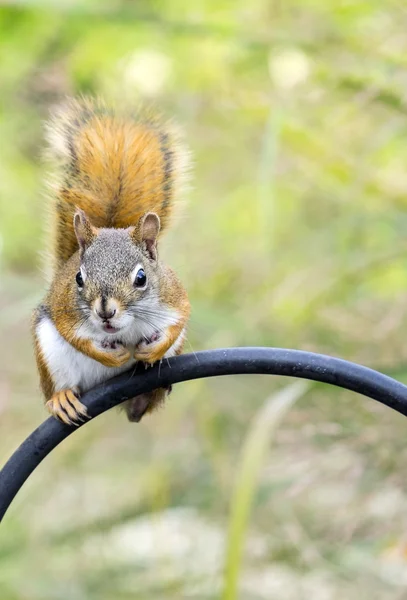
[32,98,190,425]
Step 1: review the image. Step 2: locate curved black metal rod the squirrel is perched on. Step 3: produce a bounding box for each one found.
[0,347,407,521]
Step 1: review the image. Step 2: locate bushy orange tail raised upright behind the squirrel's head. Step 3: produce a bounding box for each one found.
[47,99,188,269]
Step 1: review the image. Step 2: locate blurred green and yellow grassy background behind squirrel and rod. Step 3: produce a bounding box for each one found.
[0,0,407,600]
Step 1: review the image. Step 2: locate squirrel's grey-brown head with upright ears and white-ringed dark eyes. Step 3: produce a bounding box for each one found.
[74,210,160,337]
